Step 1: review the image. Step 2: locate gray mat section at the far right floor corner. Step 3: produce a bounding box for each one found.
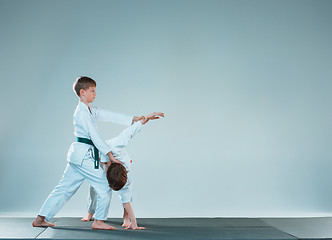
[262,217,332,239]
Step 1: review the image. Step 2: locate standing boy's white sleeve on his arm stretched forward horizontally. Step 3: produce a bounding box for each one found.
[94,107,133,126]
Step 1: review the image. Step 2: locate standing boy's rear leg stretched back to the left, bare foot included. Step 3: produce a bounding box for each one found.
[32,163,84,227]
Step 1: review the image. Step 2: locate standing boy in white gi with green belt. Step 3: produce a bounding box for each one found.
[32,77,141,230]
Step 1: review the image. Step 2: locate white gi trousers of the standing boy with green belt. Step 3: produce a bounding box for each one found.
[39,154,112,221]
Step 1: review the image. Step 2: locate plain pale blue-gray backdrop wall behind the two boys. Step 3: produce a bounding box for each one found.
[0,0,332,217]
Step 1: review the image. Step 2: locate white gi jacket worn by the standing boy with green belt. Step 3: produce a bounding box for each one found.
[67,101,133,165]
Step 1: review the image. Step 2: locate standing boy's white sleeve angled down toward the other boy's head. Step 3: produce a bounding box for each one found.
[80,112,111,155]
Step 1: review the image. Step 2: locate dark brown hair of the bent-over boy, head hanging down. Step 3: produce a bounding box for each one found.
[106,163,127,191]
